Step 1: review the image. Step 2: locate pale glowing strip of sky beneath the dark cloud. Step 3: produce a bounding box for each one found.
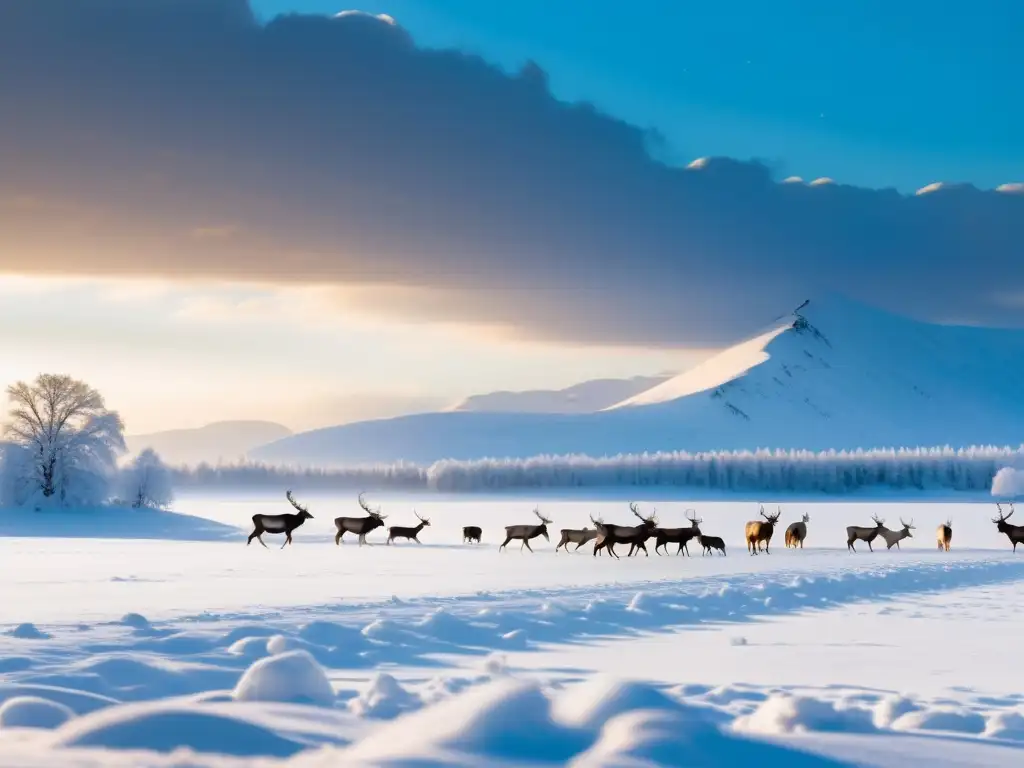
[0,274,707,434]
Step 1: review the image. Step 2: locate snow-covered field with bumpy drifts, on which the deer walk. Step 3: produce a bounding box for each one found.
[0,495,1024,768]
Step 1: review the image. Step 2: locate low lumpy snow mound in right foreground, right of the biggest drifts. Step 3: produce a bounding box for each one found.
[733,694,877,736]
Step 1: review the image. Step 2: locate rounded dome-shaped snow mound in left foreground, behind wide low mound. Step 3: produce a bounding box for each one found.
[232,650,335,707]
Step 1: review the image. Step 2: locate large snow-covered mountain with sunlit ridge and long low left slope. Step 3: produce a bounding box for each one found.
[252,297,1024,465]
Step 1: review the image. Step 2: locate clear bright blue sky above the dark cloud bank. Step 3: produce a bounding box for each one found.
[254,0,1024,190]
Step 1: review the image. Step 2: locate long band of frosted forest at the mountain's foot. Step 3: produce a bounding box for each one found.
[167,445,1024,495]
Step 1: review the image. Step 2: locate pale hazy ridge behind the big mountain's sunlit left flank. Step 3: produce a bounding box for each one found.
[449,376,671,414]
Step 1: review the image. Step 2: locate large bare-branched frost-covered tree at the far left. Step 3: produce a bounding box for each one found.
[4,374,125,506]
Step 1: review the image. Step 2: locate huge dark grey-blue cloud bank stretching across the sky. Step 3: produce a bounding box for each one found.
[0,0,1024,346]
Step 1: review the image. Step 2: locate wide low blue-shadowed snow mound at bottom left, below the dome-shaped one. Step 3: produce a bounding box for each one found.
[53,703,304,758]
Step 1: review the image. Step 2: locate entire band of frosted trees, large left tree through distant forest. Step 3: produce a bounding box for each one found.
[0,374,1024,507]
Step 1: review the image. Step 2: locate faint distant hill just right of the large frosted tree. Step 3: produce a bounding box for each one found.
[125,421,292,465]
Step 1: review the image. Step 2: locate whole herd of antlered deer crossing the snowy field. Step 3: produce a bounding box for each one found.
[246,490,1024,559]
